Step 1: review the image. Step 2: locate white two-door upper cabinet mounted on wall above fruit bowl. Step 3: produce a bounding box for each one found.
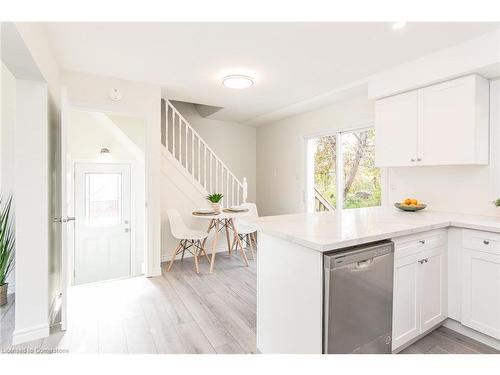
[375,75,489,167]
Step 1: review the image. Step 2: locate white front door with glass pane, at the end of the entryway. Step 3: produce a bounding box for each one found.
[74,163,131,284]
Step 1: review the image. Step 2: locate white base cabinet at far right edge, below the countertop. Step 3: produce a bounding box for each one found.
[461,230,500,339]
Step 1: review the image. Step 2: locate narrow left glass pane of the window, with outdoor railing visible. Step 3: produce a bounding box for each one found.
[314,135,337,211]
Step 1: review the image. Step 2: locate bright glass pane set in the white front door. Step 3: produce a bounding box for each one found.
[85,173,122,226]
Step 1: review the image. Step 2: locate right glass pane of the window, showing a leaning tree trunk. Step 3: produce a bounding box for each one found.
[342,129,381,208]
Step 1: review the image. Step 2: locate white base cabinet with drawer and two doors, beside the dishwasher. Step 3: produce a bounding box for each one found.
[392,231,447,350]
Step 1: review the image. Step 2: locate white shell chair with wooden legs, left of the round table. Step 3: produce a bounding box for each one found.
[167,209,210,273]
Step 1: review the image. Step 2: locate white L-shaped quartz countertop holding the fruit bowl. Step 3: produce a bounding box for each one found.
[245,207,500,252]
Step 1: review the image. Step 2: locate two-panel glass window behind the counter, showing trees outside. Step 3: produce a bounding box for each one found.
[308,128,381,211]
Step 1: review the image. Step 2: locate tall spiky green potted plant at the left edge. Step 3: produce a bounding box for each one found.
[0,197,15,306]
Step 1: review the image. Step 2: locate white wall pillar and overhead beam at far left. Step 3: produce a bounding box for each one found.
[1,23,61,343]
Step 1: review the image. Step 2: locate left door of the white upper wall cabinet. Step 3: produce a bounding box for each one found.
[375,91,418,167]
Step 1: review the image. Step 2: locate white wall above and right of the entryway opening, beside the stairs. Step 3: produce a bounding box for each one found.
[62,72,161,276]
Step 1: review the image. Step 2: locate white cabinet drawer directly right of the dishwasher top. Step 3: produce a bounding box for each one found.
[392,230,447,259]
